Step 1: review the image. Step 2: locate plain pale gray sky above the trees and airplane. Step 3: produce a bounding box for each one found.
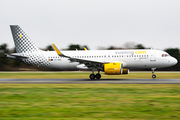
[0,0,180,49]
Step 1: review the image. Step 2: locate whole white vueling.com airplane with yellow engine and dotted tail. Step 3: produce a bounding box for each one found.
[7,25,178,80]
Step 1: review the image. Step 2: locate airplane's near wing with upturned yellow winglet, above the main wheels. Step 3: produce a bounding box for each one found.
[52,44,109,69]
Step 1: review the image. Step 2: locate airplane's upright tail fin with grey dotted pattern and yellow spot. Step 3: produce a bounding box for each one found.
[10,25,39,53]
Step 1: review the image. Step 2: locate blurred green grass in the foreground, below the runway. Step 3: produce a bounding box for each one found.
[0,84,180,120]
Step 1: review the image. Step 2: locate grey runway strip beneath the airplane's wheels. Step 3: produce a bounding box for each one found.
[0,79,180,84]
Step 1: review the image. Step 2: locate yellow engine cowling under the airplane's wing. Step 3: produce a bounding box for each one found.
[104,63,129,75]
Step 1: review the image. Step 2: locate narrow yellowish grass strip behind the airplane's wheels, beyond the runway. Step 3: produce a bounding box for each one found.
[0,72,180,79]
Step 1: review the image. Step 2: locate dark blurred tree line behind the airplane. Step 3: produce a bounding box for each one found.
[0,44,180,71]
